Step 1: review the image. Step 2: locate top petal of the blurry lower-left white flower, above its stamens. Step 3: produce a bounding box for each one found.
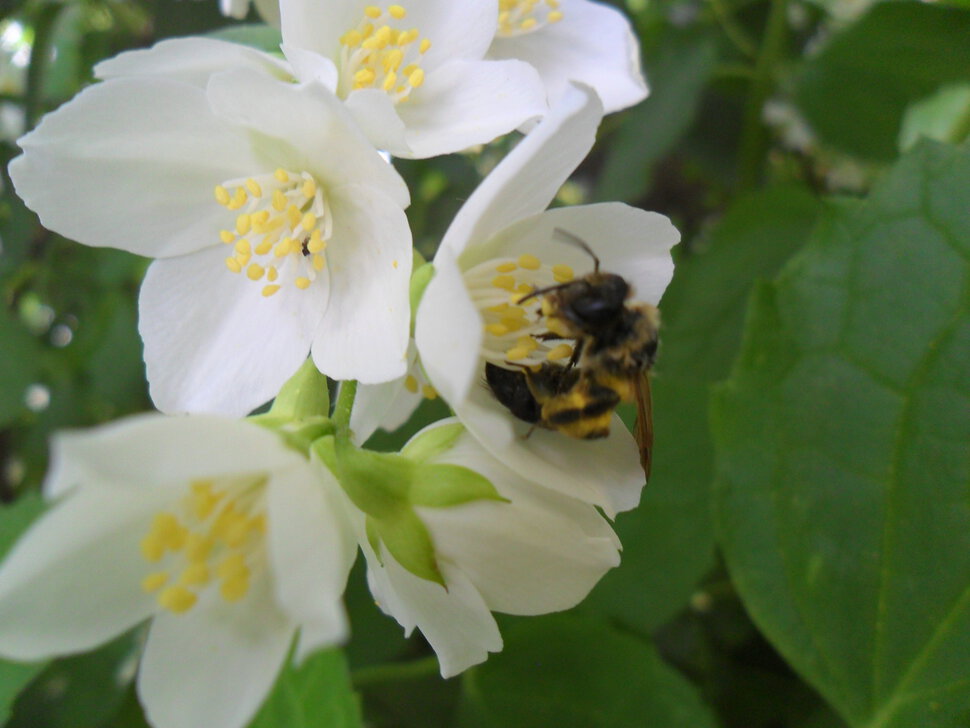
[44,413,305,499]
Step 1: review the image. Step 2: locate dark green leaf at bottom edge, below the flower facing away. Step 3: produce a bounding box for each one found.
[463,615,715,728]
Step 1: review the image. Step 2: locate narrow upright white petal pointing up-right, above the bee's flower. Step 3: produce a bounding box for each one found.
[438,86,603,255]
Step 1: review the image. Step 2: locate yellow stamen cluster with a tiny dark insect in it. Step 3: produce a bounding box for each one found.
[215,169,333,296]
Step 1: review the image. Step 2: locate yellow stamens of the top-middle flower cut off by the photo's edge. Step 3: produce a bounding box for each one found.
[337,5,431,103]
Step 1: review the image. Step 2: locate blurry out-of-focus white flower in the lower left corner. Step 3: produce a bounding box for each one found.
[0,414,356,728]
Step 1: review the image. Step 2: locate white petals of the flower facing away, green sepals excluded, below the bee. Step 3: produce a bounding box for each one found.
[359,419,620,677]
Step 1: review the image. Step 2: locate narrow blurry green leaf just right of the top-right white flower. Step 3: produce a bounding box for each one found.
[596,33,717,202]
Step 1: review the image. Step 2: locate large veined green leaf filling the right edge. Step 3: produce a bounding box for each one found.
[713,142,970,728]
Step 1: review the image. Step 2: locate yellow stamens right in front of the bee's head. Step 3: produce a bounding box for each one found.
[464,254,574,368]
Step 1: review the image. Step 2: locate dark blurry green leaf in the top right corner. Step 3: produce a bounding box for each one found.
[796,2,970,160]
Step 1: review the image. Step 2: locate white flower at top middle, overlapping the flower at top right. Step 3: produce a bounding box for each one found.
[280,0,546,158]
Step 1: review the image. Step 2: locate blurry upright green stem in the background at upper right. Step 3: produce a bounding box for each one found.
[738,0,788,191]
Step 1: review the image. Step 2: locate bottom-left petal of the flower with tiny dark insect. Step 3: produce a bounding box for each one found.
[138,247,328,415]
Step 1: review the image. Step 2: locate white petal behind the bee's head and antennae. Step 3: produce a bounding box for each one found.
[462,202,680,305]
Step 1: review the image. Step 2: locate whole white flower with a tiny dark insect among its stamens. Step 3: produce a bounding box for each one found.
[10,62,412,415]
